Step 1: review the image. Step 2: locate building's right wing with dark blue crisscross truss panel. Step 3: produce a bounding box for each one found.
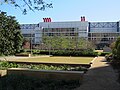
[88,22,120,48]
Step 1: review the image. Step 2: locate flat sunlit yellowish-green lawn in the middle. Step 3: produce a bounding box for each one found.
[10,56,94,64]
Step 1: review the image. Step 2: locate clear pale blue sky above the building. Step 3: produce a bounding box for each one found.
[0,0,120,24]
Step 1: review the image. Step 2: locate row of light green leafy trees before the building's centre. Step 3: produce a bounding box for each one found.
[42,35,94,50]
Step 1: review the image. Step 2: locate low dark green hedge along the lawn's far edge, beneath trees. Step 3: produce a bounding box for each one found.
[17,49,98,57]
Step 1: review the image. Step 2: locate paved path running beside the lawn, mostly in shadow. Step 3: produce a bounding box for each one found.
[74,57,120,90]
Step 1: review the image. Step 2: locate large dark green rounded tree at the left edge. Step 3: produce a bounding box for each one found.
[0,12,23,55]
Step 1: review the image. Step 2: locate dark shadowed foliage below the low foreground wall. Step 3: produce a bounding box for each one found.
[0,75,81,90]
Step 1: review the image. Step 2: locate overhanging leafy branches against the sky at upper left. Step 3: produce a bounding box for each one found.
[0,0,53,15]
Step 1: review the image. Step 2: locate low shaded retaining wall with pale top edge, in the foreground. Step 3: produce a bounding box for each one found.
[7,68,84,81]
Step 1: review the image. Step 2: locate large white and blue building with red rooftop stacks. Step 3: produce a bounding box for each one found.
[21,16,120,48]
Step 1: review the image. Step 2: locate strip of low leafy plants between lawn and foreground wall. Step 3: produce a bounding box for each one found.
[0,61,87,71]
